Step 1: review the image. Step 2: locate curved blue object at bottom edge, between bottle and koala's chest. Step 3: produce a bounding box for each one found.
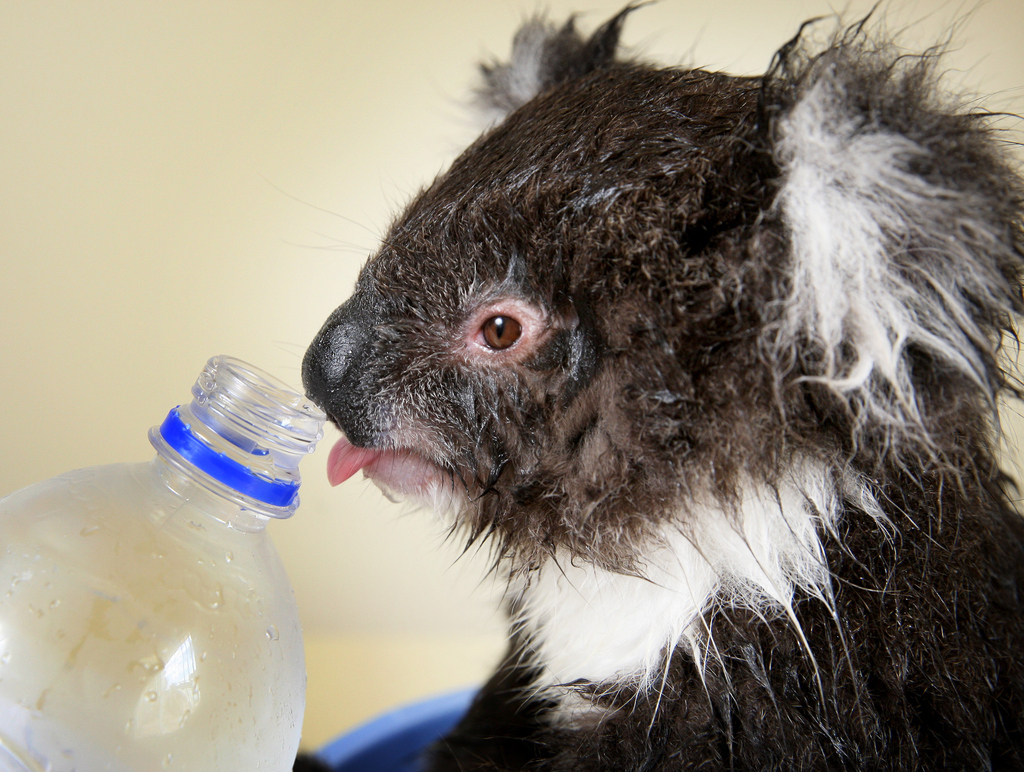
[316,688,476,772]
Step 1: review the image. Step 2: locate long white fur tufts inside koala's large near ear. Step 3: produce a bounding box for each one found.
[775,49,1012,438]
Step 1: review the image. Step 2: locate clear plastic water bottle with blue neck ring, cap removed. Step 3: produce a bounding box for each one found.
[0,357,324,772]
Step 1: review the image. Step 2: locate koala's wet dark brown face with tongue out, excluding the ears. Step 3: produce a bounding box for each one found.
[304,58,786,557]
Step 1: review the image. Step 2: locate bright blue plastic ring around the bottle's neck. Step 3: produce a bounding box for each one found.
[160,408,299,507]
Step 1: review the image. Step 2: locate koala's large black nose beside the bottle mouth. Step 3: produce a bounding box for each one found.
[302,293,384,447]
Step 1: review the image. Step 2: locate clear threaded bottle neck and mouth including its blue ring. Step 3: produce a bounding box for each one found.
[150,356,326,518]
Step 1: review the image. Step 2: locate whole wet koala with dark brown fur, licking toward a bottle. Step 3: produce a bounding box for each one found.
[303,6,1024,772]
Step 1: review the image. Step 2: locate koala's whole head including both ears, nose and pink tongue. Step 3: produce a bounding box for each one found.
[303,9,1022,570]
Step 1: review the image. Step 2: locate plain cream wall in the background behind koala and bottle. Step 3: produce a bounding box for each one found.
[0,0,1024,744]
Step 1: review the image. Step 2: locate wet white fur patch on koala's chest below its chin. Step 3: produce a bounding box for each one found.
[512,464,856,712]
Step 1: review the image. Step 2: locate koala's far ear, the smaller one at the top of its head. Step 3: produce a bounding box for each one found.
[477,4,639,120]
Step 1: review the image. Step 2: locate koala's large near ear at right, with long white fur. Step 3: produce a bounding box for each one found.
[764,27,1024,441]
